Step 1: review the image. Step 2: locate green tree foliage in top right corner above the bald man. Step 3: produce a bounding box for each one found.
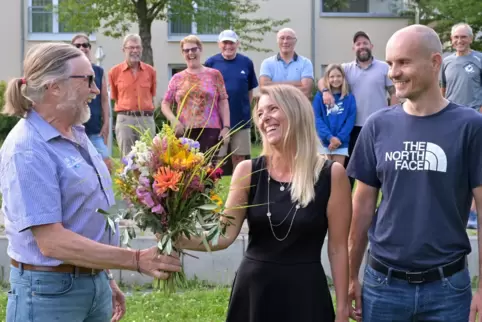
[408,0,482,50]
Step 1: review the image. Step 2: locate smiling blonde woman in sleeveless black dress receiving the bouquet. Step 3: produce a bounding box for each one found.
[178,85,351,322]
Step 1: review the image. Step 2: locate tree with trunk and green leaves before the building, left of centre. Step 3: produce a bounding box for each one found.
[56,0,289,65]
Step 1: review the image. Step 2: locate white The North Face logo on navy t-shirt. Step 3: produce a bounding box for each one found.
[385,141,447,172]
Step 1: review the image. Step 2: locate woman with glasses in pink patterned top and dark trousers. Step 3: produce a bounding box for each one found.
[162,35,230,152]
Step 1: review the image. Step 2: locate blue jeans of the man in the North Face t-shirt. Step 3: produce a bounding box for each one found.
[362,265,472,322]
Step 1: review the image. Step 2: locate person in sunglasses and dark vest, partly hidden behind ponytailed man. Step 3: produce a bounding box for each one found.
[72,34,112,170]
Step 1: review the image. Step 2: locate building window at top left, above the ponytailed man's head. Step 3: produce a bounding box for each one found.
[28,0,92,40]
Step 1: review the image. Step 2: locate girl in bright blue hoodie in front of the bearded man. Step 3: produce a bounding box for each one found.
[313,64,356,165]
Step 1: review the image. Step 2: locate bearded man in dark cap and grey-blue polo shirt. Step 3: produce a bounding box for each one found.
[318,31,398,187]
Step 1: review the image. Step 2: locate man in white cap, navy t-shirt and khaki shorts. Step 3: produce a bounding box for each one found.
[205,30,258,170]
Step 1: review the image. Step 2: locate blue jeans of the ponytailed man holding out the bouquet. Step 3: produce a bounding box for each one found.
[6,267,112,322]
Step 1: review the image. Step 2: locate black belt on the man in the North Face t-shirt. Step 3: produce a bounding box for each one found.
[368,256,467,284]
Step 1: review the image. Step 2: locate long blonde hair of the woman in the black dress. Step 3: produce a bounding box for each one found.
[254,84,326,207]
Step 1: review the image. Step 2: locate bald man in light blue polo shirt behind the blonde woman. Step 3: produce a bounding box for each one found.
[259,28,314,97]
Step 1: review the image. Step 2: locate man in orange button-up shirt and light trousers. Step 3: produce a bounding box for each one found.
[109,34,157,157]
